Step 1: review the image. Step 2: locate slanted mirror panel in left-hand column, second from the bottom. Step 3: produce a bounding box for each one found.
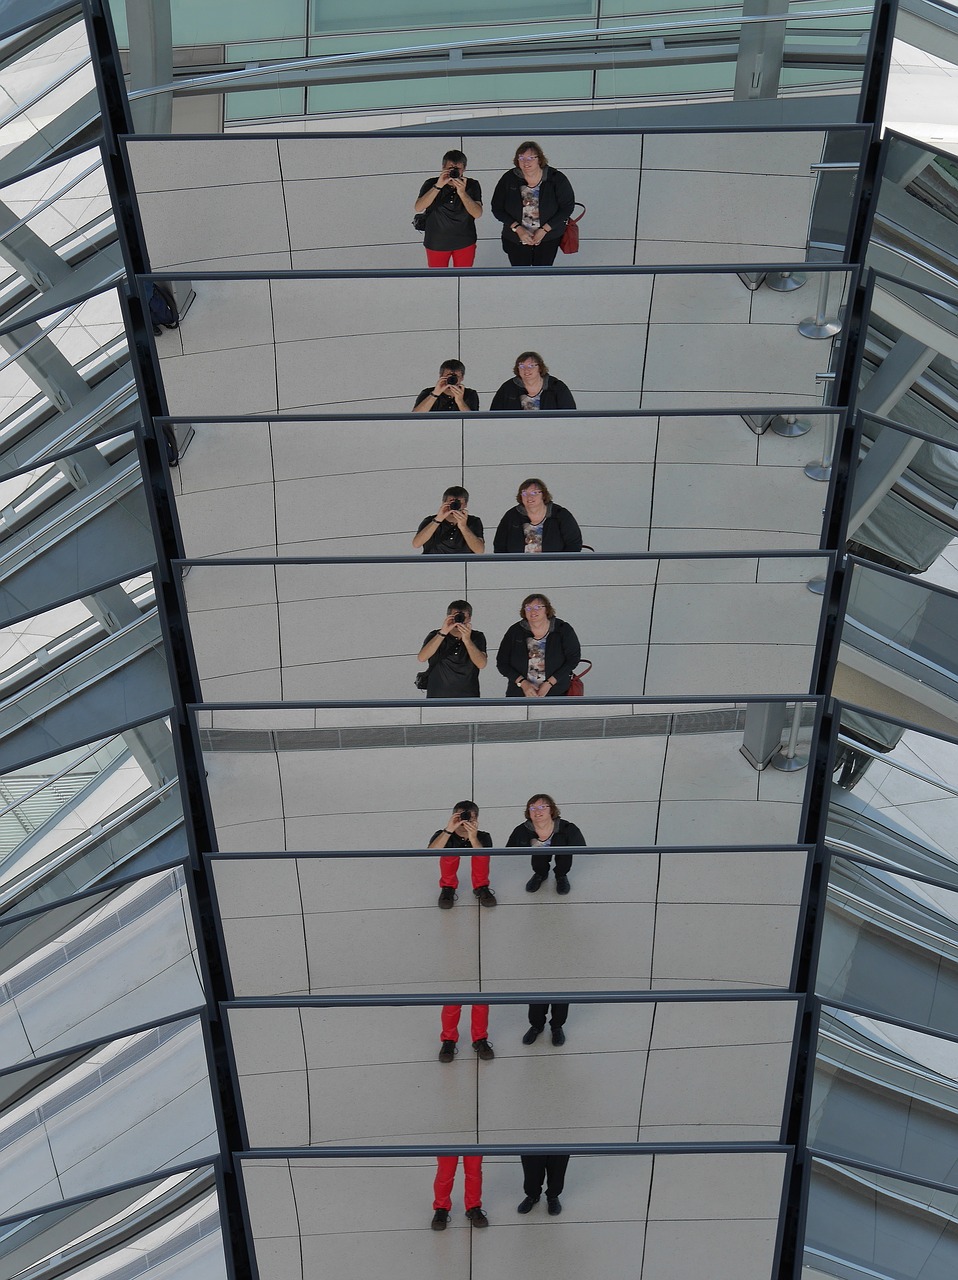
[0,1018,219,1217]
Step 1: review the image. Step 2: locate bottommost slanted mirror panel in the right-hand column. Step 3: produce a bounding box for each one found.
[802,1158,958,1280]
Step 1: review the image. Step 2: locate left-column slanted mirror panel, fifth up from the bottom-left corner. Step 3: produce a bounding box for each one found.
[0,573,173,769]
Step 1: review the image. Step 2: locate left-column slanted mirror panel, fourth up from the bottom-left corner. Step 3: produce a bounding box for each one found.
[0,719,187,914]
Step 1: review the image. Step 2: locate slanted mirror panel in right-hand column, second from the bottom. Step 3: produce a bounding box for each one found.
[808,1007,958,1187]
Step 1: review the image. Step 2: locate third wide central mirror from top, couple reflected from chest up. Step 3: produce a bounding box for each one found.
[173,412,838,558]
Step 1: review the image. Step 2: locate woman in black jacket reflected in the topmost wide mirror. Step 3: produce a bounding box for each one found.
[492,142,575,266]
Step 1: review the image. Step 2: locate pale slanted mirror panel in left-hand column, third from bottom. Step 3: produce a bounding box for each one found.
[0,867,204,1065]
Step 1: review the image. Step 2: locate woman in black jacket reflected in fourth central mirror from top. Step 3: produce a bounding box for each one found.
[496,593,581,698]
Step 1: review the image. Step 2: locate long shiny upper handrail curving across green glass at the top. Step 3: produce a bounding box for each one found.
[127,5,875,102]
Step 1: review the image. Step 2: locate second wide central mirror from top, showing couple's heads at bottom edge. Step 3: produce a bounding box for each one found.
[142,269,849,417]
